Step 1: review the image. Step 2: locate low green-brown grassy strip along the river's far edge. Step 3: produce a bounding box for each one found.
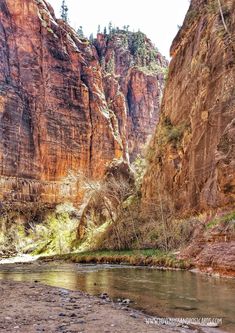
[39,249,193,269]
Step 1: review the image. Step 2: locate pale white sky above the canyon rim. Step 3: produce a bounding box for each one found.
[48,0,189,58]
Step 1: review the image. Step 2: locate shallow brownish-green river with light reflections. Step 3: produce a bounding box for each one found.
[0,262,235,333]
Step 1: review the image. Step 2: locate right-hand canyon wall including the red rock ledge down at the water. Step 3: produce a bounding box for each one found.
[141,0,235,276]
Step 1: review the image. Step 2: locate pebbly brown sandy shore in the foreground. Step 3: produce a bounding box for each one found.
[0,281,204,333]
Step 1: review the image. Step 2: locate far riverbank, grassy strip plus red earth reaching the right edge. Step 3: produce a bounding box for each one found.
[38,249,235,278]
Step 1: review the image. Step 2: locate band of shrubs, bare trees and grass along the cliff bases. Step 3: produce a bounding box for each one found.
[0,159,235,260]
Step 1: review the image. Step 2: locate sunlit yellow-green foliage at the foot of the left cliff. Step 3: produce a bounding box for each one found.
[0,204,78,255]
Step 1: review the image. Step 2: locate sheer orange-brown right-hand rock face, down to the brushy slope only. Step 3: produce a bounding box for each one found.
[142,0,235,216]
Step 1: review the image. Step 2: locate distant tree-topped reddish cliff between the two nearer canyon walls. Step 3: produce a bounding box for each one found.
[94,28,168,161]
